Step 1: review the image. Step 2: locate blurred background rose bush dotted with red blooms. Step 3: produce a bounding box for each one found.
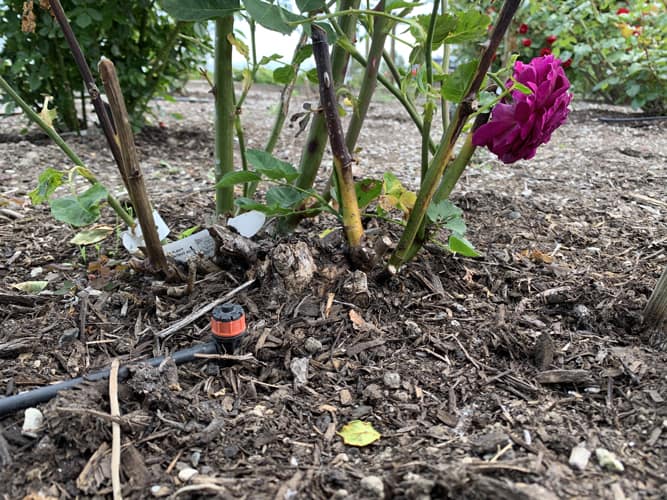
[510,0,667,114]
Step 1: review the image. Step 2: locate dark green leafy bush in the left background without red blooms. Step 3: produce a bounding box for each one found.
[0,0,209,130]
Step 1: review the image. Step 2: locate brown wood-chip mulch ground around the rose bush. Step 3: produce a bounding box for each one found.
[0,84,667,500]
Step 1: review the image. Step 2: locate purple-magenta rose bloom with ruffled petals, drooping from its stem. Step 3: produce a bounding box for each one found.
[472,55,572,163]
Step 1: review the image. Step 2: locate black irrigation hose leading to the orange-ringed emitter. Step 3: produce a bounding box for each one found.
[0,341,218,417]
